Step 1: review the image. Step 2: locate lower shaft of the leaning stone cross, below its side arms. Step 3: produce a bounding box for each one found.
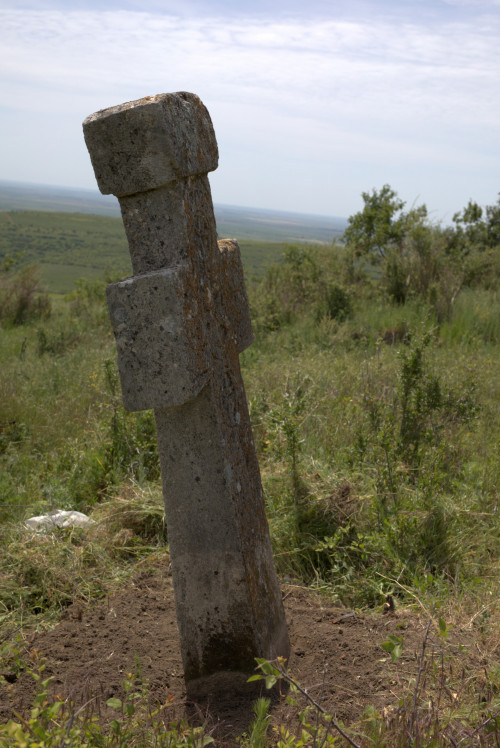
[155,380,290,689]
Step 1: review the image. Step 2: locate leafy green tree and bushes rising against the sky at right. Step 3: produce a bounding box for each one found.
[344,185,500,324]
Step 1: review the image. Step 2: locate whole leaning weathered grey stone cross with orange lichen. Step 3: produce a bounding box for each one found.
[83,93,289,692]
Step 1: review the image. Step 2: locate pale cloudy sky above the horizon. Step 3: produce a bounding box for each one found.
[0,0,500,223]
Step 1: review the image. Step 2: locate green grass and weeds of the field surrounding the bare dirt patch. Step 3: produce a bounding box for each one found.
[0,186,500,748]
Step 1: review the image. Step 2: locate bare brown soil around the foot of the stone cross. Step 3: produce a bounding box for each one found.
[0,563,490,745]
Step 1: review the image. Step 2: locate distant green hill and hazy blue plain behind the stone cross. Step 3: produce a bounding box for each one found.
[0,181,345,293]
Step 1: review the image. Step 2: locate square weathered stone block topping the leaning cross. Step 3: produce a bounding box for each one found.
[83,91,219,197]
